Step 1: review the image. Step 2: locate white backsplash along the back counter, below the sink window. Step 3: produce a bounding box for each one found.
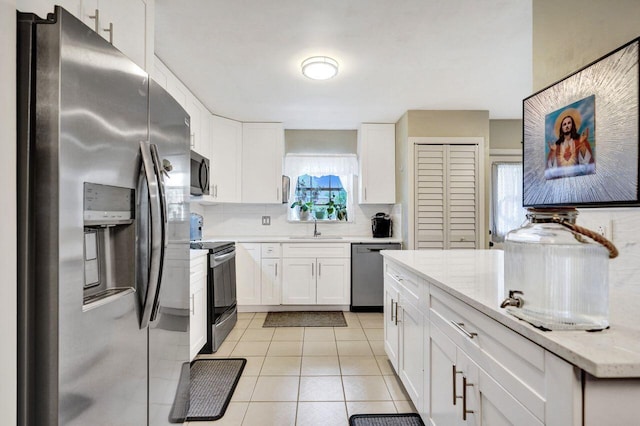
[191,203,401,239]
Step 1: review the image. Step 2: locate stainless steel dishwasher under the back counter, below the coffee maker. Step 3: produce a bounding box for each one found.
[351,243,400,312]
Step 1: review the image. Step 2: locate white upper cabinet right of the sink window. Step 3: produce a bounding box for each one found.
[358,123,396,204]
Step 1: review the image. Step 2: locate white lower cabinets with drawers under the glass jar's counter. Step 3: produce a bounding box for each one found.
[384,259,582,426]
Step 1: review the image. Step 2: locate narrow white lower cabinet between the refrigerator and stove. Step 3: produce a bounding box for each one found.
[189,251,207,360]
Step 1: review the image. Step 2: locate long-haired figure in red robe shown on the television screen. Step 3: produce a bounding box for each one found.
[545,108,595,179]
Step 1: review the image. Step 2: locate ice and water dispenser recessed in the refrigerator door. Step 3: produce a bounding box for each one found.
[83,182,136,310]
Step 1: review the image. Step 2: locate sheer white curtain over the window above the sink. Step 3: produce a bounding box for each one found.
[284,154,358,221]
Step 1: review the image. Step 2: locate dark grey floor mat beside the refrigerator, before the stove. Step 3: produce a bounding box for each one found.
[186,358,247,421]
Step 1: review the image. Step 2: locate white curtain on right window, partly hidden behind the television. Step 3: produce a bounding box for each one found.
[491,162,527,243]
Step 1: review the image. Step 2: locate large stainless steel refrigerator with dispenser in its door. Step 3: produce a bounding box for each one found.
[17,7,189,426]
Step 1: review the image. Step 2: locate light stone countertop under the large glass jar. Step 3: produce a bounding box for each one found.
[382,250,640,378]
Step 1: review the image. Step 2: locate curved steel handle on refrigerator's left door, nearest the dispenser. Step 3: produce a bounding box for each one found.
[140,141,164,329]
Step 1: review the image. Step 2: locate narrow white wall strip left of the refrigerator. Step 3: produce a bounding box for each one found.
[0,0,17,425]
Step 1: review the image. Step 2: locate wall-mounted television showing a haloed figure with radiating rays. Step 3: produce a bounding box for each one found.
[523,38,640,207]
